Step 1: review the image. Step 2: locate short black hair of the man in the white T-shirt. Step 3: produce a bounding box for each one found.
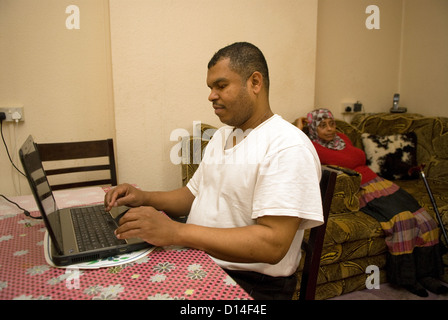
[207,42,269,92]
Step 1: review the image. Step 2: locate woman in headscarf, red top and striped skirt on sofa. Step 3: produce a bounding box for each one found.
[296,109,448,297]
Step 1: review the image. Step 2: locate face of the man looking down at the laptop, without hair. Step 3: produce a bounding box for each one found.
[207,59,254,128]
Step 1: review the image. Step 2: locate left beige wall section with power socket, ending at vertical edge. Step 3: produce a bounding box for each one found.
[0,0,115,195]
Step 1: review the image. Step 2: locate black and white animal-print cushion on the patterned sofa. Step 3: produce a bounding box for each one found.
[361,132,418,180]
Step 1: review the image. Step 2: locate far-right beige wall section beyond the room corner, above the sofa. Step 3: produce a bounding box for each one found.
[400,0,448,116]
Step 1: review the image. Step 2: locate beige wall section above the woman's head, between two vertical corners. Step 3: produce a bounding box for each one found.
[315,0,402,120]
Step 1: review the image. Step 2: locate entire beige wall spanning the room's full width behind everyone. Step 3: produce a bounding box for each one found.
[0,0,448,195]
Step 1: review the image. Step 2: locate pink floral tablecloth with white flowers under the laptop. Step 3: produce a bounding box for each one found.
[0,188,251,300]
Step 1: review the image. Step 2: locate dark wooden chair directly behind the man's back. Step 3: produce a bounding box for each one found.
[298,169,337,300]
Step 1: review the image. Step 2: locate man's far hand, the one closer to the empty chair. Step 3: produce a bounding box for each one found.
[104,183,145,211]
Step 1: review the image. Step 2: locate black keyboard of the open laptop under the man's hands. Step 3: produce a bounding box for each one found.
[70,206,126,251]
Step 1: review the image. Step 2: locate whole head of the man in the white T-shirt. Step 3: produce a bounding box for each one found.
[207,43,272,130]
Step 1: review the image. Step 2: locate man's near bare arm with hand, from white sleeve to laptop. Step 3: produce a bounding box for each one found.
[116,207,300,264]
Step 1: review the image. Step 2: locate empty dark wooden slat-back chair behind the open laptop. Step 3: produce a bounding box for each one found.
[36,139,117,190]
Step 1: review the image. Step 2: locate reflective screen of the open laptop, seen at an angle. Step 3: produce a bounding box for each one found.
[19,136,62,251]
